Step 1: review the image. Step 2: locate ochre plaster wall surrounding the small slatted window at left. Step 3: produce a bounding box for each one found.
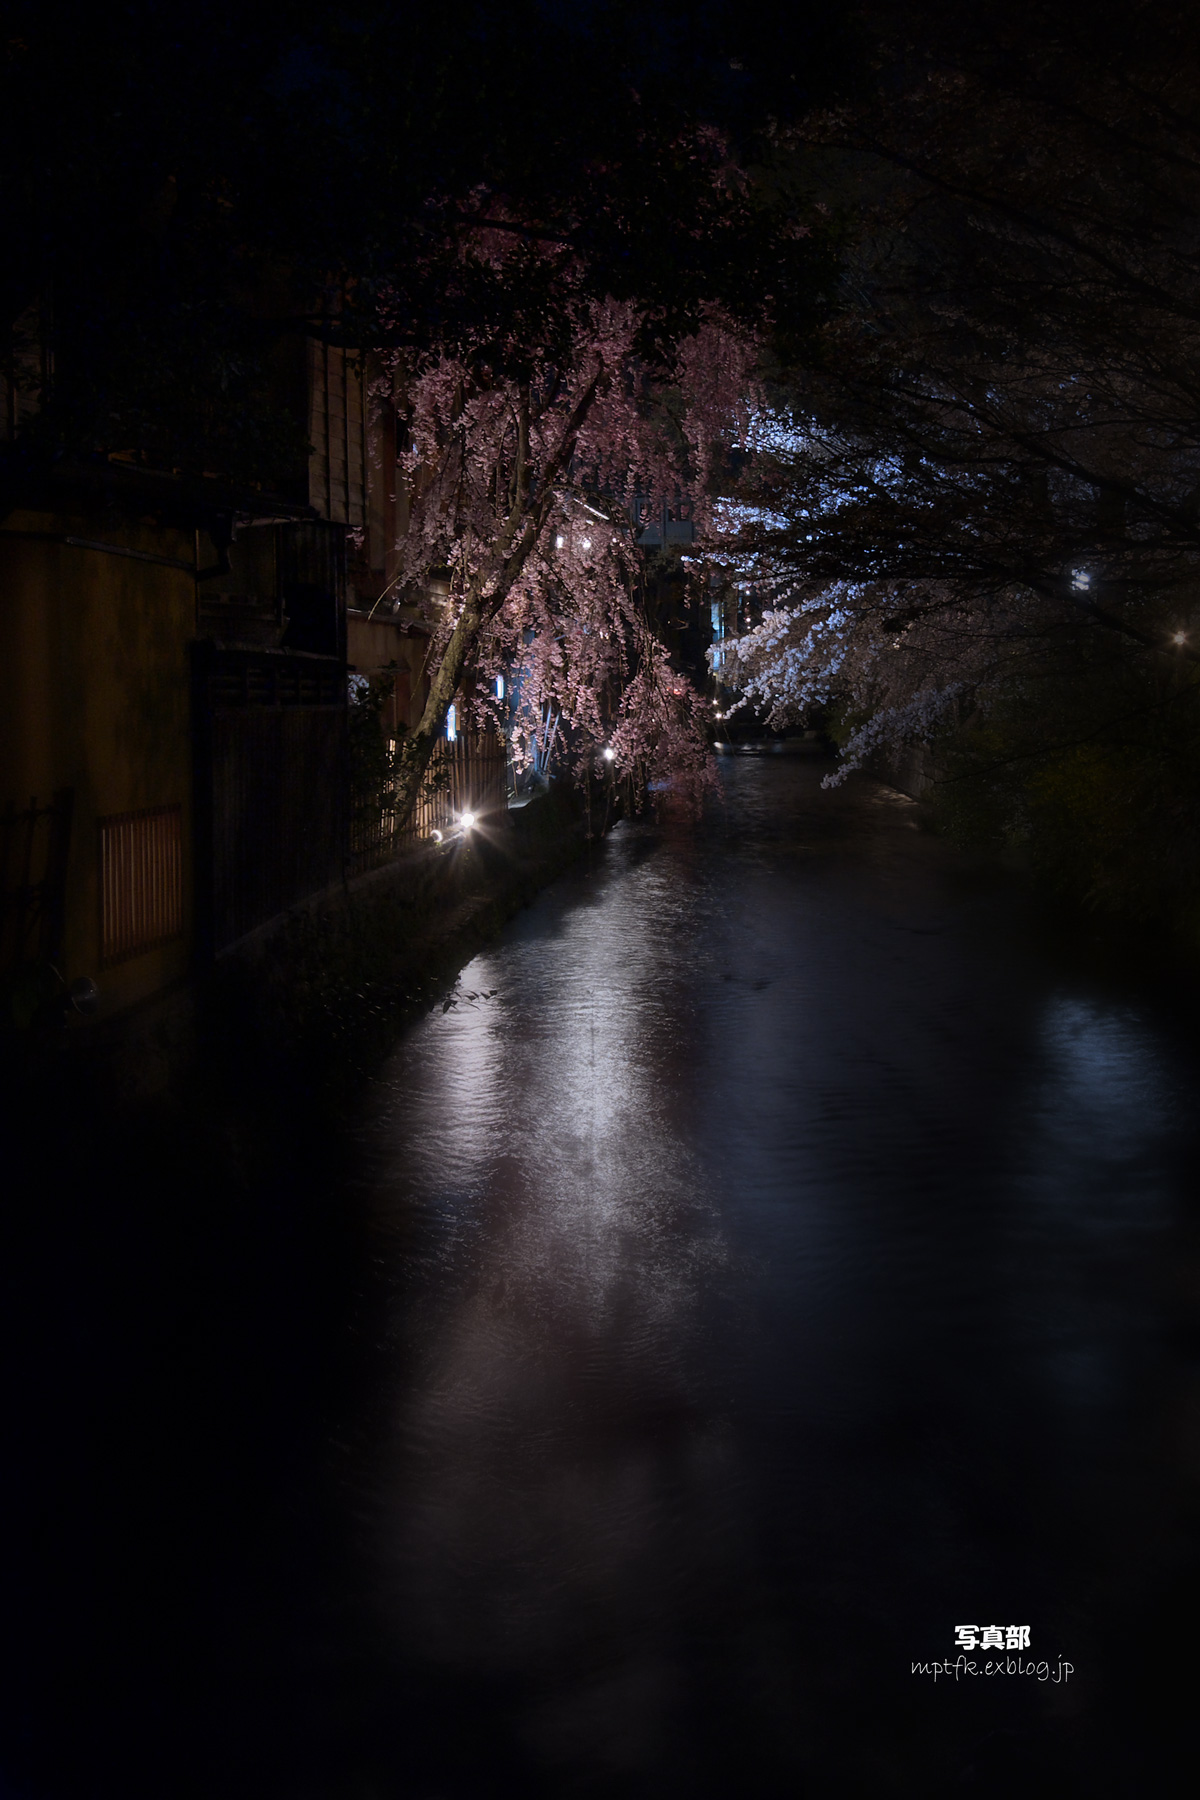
[0,513,196,1015]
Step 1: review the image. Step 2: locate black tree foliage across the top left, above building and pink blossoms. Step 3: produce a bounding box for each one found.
[0,0,853,477]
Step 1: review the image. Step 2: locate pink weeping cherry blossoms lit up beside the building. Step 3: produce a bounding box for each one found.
[379,248,754,817]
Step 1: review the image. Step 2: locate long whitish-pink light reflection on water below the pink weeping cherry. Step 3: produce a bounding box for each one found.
[367,866,730,1771]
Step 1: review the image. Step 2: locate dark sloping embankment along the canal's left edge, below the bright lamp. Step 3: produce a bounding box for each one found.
[36,783,600,1100]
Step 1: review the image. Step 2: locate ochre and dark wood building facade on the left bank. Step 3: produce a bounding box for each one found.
[0,320,363,1028]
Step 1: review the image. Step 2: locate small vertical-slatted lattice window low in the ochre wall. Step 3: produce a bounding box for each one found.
[99,806,184,967]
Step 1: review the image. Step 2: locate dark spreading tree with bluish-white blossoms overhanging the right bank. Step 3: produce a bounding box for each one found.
[712,4,1200,913]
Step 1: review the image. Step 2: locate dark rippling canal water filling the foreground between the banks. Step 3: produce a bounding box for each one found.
[0,754,1200,1800]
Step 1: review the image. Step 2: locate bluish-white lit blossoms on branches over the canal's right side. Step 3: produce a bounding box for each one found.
[709,383,1151,785]
